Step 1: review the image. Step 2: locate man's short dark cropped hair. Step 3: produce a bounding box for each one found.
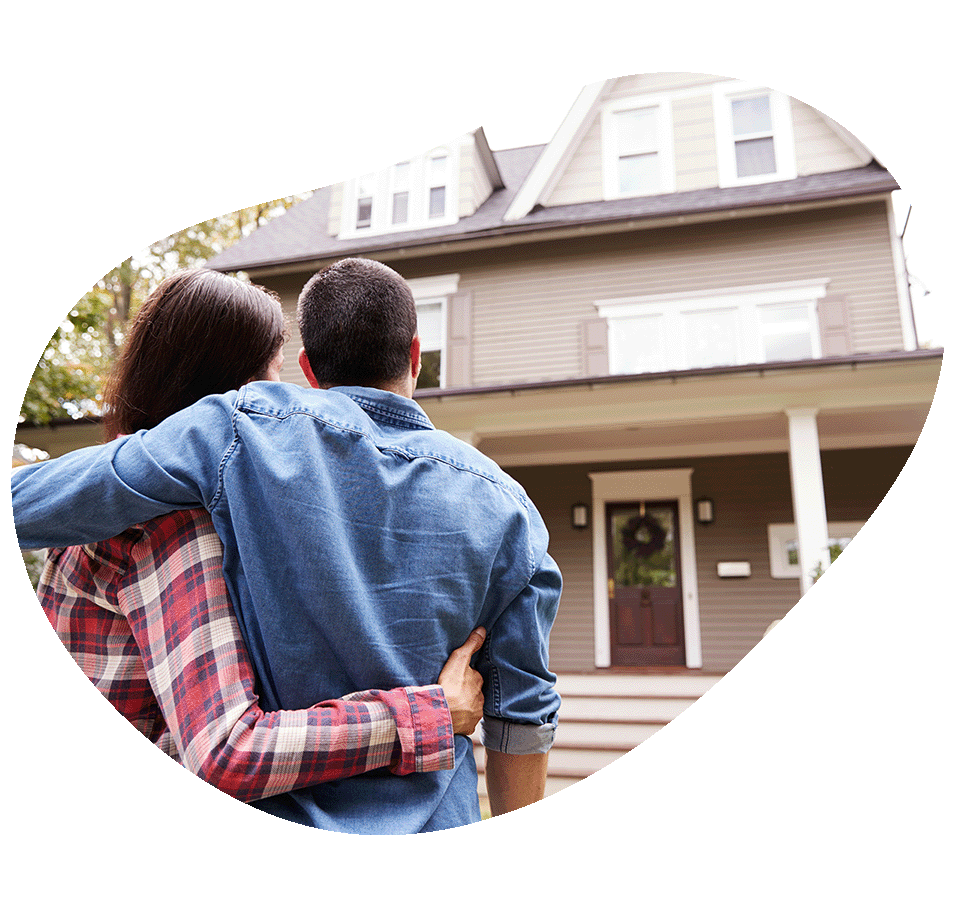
[298,259,417,387]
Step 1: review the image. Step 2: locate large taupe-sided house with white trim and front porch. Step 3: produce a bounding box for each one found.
[24,73,941,790]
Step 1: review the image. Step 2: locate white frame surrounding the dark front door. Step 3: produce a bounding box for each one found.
[590,469,702,669]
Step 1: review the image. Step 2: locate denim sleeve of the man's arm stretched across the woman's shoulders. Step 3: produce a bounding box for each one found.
[10,395,233,550]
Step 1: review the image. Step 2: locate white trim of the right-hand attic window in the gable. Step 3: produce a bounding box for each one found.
[712,81,797,187]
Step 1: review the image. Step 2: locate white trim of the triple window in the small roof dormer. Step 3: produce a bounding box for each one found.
[338,141,461,240]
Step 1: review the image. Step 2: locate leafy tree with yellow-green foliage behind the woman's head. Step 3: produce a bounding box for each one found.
[20,194,308,425]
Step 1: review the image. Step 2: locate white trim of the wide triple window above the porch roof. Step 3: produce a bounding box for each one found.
[594,278,829,374]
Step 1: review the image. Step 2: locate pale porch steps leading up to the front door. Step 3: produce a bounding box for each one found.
[474,673,722,813]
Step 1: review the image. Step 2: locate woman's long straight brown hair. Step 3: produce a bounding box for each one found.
[103,269,285,440]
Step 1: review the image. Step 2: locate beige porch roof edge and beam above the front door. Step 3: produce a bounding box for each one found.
[415,350,942,466]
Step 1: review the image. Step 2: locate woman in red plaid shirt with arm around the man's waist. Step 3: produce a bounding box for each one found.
[37,270,483,802]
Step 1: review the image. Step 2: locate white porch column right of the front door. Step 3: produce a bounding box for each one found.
[785,409,831,595]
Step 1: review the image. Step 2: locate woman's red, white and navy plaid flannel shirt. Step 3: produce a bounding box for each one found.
[37,510,454,802]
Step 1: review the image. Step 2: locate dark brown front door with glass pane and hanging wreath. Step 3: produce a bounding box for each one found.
[606,500,686,666]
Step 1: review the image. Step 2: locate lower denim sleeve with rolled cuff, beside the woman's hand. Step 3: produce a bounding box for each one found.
[477,555,563,755]
